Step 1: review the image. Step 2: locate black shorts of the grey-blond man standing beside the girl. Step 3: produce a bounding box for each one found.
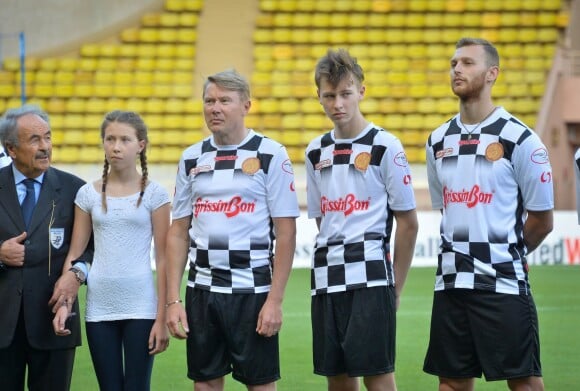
[185,287,280,385]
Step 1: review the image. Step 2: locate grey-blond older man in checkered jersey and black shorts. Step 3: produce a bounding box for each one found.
[167,71,299,391]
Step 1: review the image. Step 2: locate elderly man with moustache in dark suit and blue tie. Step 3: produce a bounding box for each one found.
[0,105,91,391]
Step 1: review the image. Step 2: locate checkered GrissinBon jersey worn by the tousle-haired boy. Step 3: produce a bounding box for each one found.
[306,123,415,295]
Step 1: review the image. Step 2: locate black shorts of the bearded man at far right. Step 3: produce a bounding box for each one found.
[423,289,542,381]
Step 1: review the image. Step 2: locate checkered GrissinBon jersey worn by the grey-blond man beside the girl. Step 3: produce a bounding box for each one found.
[173,130,300,293]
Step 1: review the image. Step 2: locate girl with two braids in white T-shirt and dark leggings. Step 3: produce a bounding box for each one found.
[53,111,170,391]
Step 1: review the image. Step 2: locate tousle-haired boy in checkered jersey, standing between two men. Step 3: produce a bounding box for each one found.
[306,49,417,390]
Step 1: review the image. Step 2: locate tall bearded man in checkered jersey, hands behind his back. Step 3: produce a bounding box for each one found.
[423,38,554,390]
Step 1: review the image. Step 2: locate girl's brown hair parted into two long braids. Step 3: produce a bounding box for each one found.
[101,110,149,213]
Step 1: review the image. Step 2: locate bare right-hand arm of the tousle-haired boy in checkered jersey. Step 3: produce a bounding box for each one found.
[393,209,419,308]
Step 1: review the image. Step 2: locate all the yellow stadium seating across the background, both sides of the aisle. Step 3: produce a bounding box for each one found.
[0,0,569,163]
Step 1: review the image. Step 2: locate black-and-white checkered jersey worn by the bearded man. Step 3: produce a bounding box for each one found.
[426,107,554,294]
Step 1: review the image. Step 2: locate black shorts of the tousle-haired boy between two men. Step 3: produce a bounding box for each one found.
[311,286,396,377]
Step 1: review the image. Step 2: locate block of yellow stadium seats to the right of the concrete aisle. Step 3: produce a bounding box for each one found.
[252,0,568,163]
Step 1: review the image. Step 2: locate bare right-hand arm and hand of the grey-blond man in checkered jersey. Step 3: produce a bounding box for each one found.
[256,217,296,337]
